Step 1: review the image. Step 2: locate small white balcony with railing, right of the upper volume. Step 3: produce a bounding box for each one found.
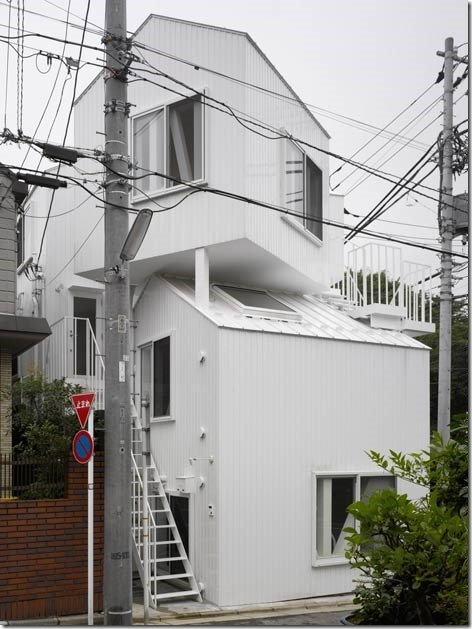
[334,243,435,337]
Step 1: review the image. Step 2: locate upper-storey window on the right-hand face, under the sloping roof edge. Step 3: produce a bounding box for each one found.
[284,140,323,240]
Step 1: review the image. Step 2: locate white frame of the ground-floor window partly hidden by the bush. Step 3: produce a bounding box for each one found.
[311,470,397,567]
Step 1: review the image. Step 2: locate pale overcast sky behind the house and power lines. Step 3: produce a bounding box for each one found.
[0,0,468,293]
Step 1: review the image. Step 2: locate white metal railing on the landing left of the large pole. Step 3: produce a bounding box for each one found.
[45,317,105,410]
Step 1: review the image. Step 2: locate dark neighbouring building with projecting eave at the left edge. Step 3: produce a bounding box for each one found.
[0,164,51,466]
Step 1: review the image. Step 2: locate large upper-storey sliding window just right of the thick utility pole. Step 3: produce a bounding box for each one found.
[132,97,203,197]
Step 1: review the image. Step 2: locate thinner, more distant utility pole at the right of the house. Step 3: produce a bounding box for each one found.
[438,37,455,442]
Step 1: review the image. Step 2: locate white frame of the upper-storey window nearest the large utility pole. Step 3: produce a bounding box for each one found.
[129,89,207,203]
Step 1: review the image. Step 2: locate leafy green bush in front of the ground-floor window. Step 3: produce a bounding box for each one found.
[345,434,468,625]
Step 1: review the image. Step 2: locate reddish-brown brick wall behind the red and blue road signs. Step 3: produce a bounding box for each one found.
[0,453,103,623]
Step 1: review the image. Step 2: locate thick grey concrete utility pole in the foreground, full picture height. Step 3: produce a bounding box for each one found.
[103,0,133,626]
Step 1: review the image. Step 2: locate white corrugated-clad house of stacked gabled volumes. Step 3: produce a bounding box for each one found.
[19,15,431,605]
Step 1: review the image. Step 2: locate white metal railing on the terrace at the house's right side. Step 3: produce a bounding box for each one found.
[334,243,432,323]
